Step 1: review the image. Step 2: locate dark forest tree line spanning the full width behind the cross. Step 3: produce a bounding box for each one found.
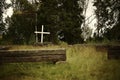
[0,0,120,44]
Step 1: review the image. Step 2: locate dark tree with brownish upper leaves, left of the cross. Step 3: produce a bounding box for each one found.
[8,0,35,44]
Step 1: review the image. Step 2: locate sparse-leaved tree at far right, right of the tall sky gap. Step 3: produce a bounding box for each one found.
[94,0,120,40]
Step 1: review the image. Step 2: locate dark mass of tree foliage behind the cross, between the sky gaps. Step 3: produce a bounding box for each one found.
[4,0,83,44]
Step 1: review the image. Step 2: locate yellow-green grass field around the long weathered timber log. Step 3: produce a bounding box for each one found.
[0,45,120,80]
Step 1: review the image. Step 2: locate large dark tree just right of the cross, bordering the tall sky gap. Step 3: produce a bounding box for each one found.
[38,0,83,44]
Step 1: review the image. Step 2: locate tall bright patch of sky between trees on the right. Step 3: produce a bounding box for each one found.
[82,0,97,39]
